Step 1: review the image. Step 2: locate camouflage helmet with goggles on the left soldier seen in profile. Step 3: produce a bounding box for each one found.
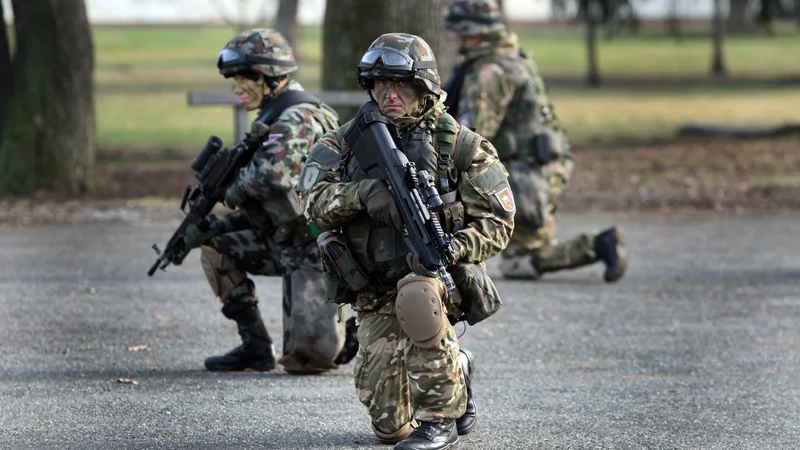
[217,28,297,77]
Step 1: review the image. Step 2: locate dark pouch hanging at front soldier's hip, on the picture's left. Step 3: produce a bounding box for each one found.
[317,231,369,304]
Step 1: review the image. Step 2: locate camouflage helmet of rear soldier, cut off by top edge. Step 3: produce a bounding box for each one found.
[444,0,506,36]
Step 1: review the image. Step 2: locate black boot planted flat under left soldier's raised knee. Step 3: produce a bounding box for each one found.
[205,303,275,372]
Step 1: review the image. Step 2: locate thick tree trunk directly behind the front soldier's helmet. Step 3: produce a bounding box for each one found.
[322,0,457,100]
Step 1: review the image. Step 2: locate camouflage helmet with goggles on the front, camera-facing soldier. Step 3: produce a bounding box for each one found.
[358,33,441,95]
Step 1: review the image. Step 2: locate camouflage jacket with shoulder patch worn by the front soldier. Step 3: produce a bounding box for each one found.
[301,102,514,311]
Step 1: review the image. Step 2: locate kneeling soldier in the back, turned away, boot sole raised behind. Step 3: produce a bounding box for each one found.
[443,0,627,282]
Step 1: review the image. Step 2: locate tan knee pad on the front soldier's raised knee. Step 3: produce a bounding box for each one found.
[395,274,450,348]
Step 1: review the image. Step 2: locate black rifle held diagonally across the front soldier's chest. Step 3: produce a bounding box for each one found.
[344,101,455,292]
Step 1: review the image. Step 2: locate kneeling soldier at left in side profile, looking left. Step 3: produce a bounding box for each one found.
[185,29,344,374]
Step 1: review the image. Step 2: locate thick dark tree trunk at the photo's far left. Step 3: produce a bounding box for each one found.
[0,0,94,194]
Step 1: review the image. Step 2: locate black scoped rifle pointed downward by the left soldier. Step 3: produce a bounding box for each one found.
[147,133,261,277]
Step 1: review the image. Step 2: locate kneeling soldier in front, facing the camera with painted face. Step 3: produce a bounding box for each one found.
[298,33,514,450]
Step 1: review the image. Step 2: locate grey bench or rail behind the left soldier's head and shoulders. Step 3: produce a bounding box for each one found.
[187,91,369,142]
